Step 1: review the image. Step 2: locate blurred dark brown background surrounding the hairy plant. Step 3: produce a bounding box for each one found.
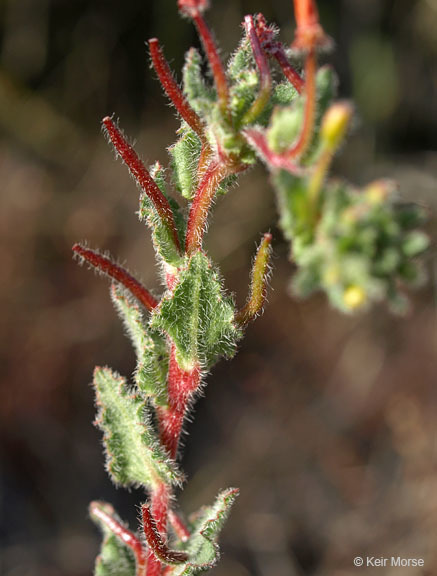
[0,0,437,576]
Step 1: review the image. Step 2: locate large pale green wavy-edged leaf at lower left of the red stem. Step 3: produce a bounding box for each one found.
[94,368,180,488]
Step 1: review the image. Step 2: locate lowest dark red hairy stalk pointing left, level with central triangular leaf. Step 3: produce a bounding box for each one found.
[73,244,158,311]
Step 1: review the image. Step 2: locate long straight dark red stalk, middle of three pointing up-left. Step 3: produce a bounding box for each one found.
[102,116,180,251]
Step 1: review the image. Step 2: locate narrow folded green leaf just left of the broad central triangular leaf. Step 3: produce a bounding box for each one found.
[111,286,169,406]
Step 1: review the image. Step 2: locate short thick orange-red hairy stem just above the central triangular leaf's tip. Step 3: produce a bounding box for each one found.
[185,162,228,254]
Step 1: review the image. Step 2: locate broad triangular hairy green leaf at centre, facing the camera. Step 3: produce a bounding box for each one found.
[151,252,241,370]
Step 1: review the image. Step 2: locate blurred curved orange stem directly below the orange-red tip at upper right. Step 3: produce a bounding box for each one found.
[286,50,317,158]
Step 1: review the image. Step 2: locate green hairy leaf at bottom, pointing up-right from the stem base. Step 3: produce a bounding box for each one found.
[172,488,238,576]
